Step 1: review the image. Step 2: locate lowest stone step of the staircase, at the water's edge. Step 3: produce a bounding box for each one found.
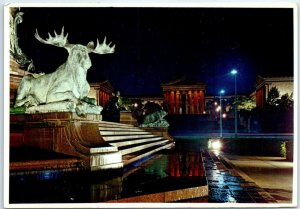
[122,142,174,166]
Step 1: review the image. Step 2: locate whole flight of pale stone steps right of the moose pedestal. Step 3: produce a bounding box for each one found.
[99,121,174,166]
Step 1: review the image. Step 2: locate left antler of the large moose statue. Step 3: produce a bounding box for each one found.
[34,27,68,47]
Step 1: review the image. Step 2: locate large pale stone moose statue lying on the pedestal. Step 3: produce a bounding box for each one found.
[14,27,115,116]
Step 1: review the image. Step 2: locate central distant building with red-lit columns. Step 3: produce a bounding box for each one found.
[162,79,206,114]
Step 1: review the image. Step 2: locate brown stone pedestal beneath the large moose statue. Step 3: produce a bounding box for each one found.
[10,112,123,170]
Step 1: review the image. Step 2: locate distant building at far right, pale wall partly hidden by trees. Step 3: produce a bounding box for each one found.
[253,76,294,108]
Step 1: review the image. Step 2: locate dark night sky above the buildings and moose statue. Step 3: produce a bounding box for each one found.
[18,8,293,96]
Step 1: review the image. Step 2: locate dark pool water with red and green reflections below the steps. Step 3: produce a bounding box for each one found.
[10,140,206,203]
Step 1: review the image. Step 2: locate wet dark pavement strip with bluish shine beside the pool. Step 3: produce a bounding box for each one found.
[203,150,277,203]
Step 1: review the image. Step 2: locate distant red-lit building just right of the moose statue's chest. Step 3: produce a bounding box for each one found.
[88,80,114,107]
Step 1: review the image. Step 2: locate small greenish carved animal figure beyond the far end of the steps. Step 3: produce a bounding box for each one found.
[140,110,170,128]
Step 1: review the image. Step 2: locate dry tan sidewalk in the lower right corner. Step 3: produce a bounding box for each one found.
[221,153,295,203]
